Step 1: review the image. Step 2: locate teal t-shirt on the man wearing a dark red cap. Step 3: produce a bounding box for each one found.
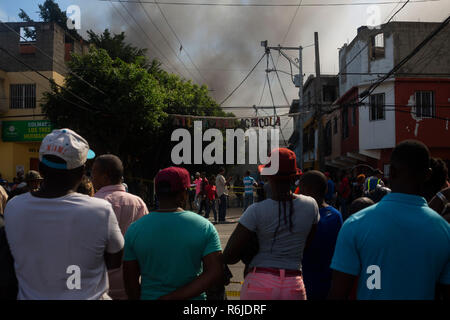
[123,211,222,300]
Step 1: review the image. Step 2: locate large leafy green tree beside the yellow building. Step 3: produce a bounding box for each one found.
[42,30,226,179]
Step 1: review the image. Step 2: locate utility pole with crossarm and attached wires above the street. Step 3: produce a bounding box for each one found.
[261,40,303,169]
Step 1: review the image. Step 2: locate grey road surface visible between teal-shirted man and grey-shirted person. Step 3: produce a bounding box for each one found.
[205,208,244,300]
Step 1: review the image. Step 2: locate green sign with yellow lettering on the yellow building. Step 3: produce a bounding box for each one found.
[2,120,53,142]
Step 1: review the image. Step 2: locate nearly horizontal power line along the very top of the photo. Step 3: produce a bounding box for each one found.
[103,0,441,7]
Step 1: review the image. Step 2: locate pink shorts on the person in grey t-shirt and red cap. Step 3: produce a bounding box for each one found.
[241,269,306,300]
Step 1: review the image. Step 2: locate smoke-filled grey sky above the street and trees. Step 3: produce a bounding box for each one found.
[0,0,450,140]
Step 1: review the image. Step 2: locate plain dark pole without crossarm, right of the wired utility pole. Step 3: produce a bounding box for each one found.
[314,32,325,171]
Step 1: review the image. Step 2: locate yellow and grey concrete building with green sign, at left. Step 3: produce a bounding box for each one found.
[0,22,88,181]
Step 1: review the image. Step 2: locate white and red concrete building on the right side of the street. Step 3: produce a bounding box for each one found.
[327,22,450,176]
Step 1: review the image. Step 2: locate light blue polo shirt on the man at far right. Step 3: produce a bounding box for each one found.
[331,193,450,300]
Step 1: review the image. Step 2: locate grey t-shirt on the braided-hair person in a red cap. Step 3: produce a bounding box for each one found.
[239,195,320,270]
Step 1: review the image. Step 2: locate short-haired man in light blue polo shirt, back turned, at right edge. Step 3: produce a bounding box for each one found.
[329,141,450,300]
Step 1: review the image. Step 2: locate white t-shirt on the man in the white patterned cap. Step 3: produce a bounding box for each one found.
[5,193,124,300]
